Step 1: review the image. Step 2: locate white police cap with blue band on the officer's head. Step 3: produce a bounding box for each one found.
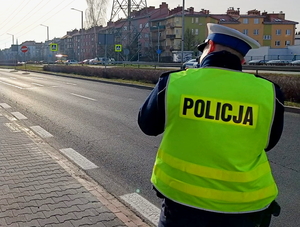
[198,23,260,56]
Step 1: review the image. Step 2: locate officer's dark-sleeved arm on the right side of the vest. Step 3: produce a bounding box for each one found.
[265,84,284,151]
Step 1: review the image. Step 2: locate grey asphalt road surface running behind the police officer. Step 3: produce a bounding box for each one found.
[0,70,300,227]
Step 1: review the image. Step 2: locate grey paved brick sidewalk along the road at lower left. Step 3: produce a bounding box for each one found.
[0,106,149,227]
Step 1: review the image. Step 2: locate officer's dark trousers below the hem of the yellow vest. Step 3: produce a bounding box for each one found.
[158,199,280,227]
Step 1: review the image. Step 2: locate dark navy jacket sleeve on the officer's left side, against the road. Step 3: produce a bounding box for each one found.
[138,73,169,136]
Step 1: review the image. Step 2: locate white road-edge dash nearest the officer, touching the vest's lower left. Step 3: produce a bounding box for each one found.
[120,193,160,226]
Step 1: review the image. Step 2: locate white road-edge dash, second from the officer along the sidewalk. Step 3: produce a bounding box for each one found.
[60,148,98,170]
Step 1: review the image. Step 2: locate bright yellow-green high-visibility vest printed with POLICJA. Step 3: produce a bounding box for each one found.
[151,68,278,213]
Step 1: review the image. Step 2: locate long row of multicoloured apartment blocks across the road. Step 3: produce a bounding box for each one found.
[4,2,299,62]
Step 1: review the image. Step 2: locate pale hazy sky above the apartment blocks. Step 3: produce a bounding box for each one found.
[0,0,300,49]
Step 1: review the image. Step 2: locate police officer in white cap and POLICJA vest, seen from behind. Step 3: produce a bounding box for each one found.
[138,23,284,227]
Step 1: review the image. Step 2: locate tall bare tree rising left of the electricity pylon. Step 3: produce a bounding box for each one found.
[85,0,107,28]
